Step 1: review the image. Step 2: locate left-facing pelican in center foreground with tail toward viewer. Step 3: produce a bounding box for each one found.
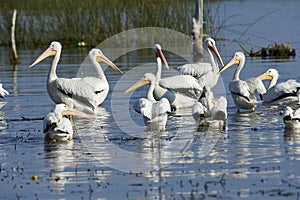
[124,73,171,130]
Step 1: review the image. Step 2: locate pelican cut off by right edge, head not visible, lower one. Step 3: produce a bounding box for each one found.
[283,106,300,129]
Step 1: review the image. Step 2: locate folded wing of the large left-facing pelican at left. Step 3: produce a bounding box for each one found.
[55,78,96,108]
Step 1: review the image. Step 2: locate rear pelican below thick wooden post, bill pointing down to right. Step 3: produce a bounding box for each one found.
[178,38,224,88]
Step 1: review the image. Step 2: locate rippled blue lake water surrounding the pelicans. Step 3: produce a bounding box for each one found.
[0,0,300,199]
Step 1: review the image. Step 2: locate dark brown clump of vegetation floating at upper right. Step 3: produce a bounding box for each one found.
[239,42,296,58]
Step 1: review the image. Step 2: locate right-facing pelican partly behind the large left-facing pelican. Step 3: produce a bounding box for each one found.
[74,49,123,106]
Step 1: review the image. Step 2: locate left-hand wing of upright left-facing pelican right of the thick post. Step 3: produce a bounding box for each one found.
[229,80,250,101]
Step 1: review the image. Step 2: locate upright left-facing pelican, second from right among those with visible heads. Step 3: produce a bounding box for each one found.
[220,52,259,112]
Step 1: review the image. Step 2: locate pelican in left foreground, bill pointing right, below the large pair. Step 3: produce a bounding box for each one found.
[43,103,93,141]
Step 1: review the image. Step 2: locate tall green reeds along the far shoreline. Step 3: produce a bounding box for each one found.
[0,0,216,47]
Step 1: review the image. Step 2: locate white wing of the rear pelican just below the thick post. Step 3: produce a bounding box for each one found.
[177,63,212,78]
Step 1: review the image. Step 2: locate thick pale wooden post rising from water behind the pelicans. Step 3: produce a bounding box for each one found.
[192,0,203,62]
